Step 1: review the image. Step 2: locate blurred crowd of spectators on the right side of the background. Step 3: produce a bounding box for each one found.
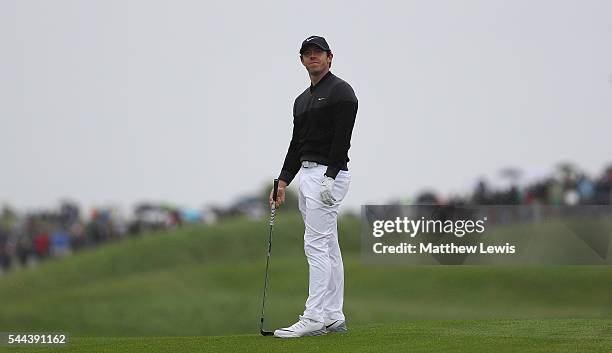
[398,163,612,224]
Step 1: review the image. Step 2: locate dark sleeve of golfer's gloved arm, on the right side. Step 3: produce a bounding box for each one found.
[325,82,358,179]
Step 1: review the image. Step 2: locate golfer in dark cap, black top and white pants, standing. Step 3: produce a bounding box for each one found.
[270,36,357,337]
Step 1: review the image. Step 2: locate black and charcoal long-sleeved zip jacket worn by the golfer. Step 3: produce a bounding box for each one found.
[279,72,357,184]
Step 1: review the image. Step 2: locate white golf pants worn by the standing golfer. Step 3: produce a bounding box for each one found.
[299,165,351,322]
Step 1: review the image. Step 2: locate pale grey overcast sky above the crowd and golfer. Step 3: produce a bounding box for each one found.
[0,0,612,209]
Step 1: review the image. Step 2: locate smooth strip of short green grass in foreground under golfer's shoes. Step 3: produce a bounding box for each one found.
[7,320,612,353]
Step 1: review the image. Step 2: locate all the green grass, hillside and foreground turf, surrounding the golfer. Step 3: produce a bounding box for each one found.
[0,212,612,352]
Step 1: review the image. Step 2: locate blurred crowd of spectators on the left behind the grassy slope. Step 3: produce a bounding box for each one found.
[0,201,227,273]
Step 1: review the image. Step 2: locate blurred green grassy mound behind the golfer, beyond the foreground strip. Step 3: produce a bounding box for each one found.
[0,213,612,336]
